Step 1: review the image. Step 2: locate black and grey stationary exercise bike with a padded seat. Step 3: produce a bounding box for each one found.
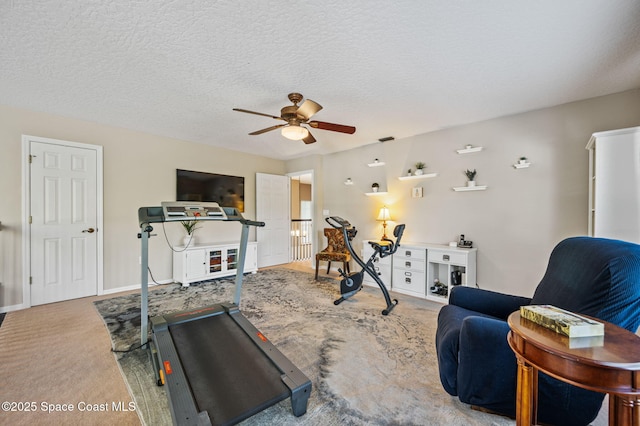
[325,216,404,315]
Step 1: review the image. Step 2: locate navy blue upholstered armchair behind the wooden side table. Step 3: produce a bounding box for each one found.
[436,237,640,426]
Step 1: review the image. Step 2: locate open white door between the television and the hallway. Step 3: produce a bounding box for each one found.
[256,173,291,268]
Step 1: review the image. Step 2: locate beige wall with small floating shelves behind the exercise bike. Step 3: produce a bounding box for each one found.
[310,90,640,296]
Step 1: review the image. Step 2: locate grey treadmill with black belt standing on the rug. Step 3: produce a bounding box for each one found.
[138,202,311,425]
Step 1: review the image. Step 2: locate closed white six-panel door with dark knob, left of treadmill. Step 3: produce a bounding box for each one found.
[29,138,102,305]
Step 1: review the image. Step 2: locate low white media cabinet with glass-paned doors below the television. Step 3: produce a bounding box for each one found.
[173,242,258,287]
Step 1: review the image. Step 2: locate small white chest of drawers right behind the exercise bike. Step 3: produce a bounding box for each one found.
[391,244,427,297]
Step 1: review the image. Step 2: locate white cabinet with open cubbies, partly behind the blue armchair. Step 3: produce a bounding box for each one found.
[426,245,477,303]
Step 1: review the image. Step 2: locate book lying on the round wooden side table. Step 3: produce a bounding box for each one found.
[520,305,604,337]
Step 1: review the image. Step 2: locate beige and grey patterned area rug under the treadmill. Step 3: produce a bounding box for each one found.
[95,268,515,426]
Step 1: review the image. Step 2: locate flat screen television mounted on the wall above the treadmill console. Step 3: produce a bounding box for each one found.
[176,169,244,212]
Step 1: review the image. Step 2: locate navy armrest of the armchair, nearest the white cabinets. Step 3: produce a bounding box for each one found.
[449,286,531,320]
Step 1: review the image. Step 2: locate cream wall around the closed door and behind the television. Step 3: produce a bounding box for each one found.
[0,106,285,310]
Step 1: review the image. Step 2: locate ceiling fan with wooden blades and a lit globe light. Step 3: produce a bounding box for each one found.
[233,93,356,144]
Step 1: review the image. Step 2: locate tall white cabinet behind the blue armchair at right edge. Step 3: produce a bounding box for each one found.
[587,127,640,243]
